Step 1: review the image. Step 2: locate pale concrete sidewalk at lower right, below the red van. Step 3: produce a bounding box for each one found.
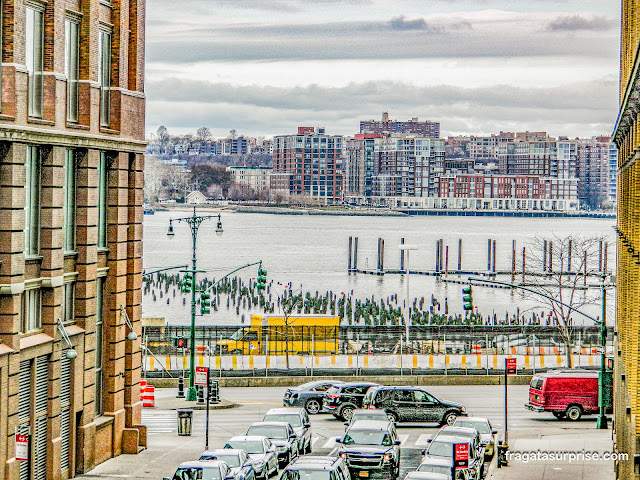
[486,428,615,480]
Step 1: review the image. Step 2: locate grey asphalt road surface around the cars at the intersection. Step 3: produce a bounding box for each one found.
[139,385,595,478]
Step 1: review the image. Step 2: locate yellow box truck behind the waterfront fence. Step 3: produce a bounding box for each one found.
[217,314,340,355]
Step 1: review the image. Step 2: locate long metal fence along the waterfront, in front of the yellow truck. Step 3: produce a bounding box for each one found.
[143,325,613,355]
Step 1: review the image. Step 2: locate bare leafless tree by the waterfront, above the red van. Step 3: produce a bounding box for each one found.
[520,235,604,367]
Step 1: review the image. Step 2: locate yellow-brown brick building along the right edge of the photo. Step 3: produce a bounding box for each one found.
[613,0,640,480]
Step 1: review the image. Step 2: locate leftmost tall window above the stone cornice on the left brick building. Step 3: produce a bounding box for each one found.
[25,3,44,118]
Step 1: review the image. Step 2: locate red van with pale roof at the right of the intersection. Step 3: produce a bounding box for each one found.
[525,370,611,421]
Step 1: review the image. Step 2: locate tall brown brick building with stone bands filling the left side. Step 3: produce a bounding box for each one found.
[0,0,146,480]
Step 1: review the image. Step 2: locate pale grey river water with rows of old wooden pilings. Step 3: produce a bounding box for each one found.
[142,209,615,325]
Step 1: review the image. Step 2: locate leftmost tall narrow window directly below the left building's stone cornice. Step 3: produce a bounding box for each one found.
[24,145,40,256]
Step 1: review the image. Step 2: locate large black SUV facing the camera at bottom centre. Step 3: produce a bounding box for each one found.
[336,420,400,480]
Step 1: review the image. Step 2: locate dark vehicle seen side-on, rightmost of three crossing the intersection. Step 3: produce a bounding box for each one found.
[363,387,467,425]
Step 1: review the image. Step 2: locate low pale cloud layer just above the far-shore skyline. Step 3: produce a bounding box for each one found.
[147,79,617,136]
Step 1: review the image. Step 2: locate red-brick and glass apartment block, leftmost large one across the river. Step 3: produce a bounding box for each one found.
[273,127,344,204]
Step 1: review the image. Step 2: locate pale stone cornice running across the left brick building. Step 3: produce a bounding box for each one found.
[0,124,147,153]
